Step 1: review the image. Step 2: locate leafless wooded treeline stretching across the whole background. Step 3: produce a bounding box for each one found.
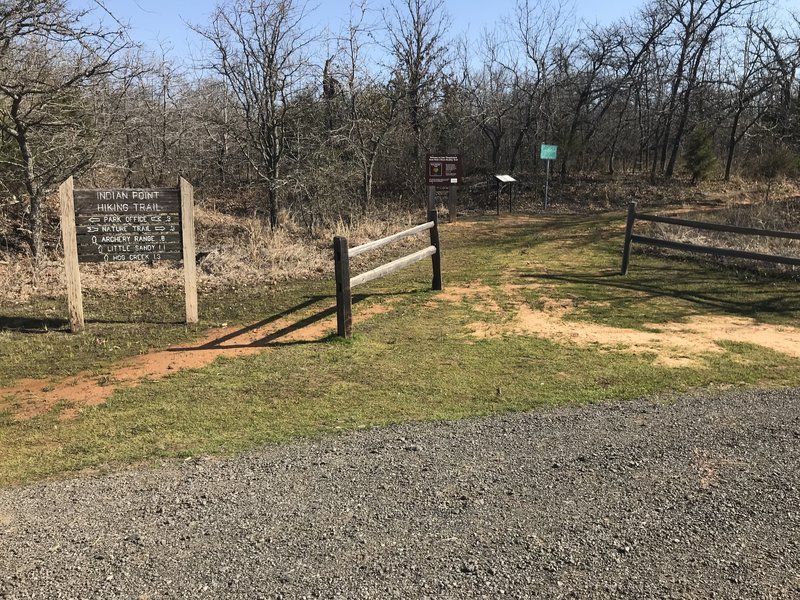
[0,0,800,254]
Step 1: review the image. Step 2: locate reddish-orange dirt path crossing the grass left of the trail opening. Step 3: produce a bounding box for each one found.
[0,297,394,420]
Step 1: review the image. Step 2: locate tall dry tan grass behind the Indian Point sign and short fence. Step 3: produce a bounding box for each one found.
[0,208,421,304]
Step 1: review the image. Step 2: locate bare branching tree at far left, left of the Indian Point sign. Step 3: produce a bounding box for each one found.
[0,0,129,257]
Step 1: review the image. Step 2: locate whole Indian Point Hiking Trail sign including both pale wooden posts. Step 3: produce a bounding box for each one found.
[58,177,198,333]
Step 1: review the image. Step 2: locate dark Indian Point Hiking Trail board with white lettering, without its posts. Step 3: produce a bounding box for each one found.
[74,188,183,262]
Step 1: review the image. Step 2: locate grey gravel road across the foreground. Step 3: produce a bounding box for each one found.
[0,390,800,599]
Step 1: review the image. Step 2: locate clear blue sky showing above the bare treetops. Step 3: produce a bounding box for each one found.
[84,0,645,60]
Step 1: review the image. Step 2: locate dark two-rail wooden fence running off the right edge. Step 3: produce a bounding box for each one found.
[622,202,800,275]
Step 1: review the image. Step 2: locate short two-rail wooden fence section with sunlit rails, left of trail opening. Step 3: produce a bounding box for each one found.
[333,210,442,338]
